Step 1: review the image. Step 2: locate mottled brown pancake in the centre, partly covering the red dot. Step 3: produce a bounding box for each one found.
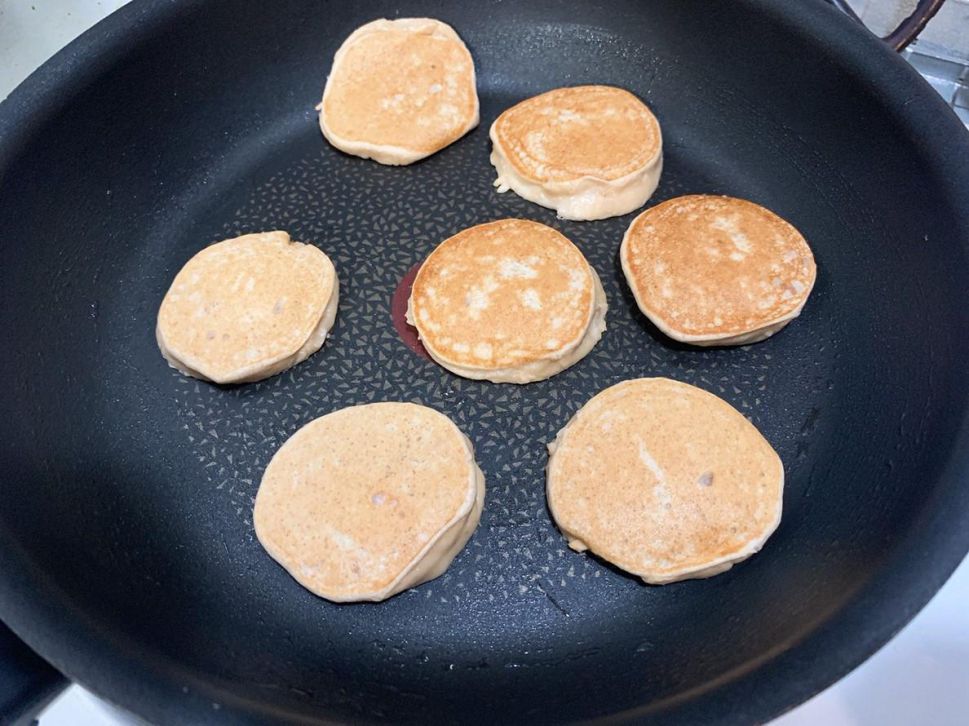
[407,219,607,383]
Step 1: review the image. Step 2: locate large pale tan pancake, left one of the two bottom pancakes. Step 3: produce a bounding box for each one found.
[253,403,484,602]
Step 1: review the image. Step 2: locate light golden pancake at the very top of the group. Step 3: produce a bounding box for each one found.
[317,18,478,165]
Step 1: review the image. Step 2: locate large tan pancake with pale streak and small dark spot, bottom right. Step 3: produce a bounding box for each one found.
[547,378,784,585]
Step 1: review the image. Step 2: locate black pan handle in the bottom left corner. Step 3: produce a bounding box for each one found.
[0,622,67,724]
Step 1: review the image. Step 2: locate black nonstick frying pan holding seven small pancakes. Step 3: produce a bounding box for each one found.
[0,0,969,723]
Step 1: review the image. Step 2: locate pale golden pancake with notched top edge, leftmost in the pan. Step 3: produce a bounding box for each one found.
[155,232,340,383]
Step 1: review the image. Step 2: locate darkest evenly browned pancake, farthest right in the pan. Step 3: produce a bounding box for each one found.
[619,195,817,345]
